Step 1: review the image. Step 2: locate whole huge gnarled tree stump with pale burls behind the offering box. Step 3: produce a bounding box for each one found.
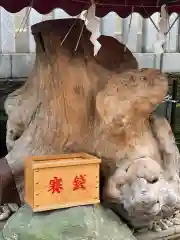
[0,19,180,230]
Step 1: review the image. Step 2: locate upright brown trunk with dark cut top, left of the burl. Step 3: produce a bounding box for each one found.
[5,19,137,201]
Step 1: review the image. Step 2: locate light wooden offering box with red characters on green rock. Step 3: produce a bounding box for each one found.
[25,153,101,212]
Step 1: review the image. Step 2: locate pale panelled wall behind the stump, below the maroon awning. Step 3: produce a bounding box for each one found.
[0,8,180,78]
